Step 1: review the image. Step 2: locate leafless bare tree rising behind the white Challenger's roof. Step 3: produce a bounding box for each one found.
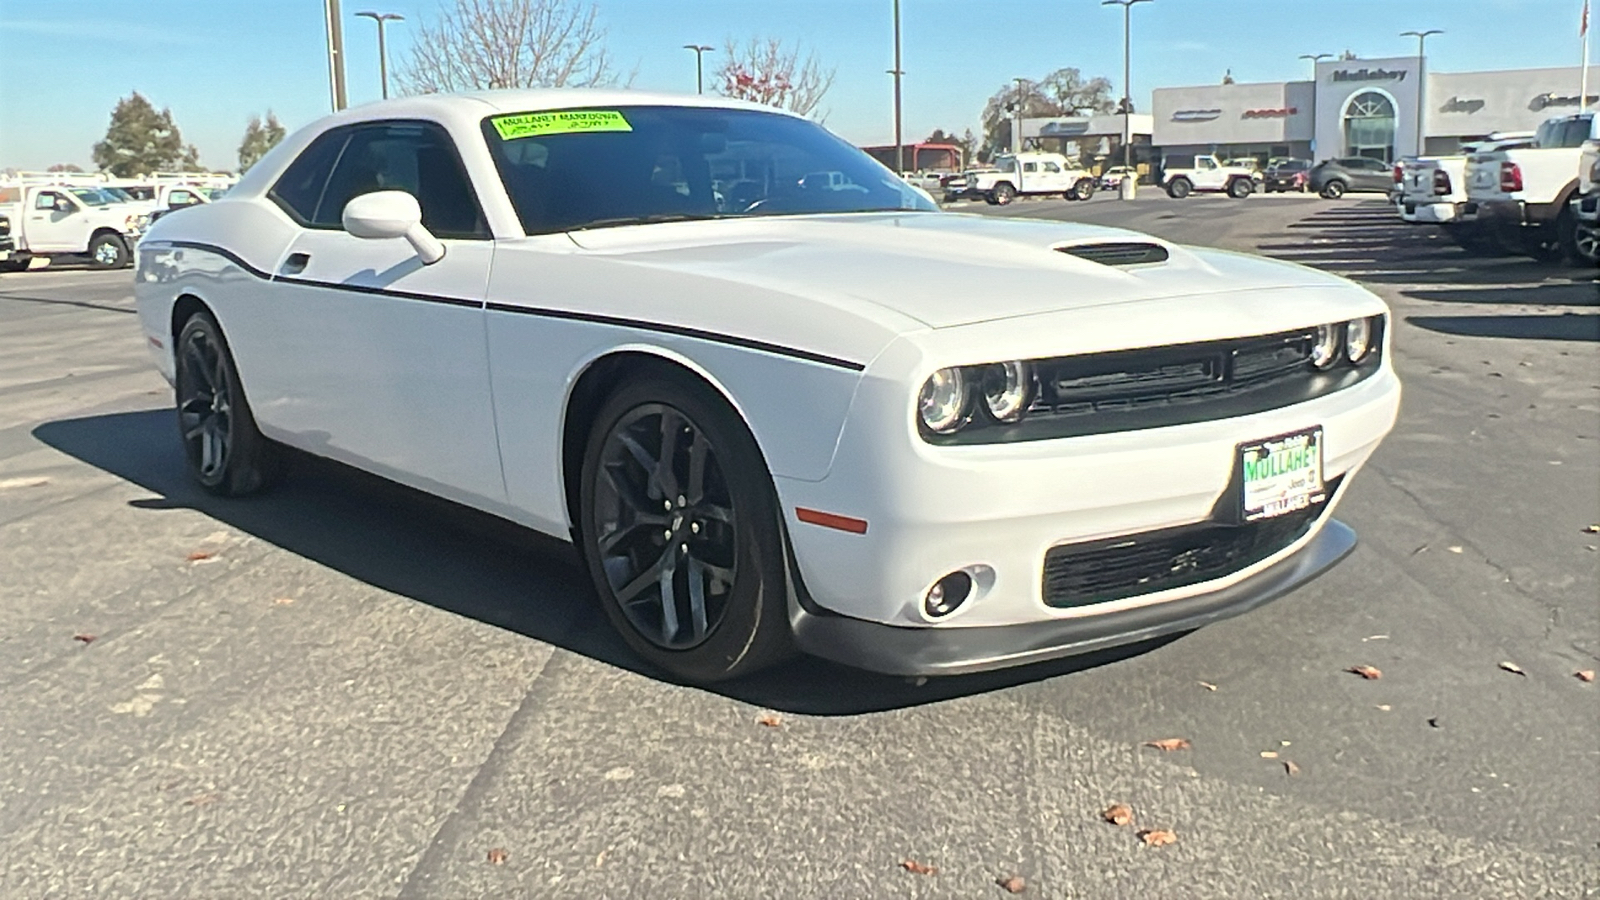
[395,0,632,94]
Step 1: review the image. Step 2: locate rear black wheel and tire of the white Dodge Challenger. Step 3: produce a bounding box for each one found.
[174,312,282,496]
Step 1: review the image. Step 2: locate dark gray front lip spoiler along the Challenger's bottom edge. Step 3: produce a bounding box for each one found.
[790,519,1355,676]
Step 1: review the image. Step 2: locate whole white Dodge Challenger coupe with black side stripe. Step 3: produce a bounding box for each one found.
[136,90,1400,682]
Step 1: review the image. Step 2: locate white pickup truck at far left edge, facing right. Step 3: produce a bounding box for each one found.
[0,184,149,271]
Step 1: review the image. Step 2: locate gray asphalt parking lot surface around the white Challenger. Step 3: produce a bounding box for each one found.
[0,195,1600,898]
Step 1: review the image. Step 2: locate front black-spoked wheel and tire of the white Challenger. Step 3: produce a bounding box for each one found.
[579,367,794,684]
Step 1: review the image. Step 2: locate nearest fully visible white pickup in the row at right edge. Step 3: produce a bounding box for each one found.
[1461,112,1600,264]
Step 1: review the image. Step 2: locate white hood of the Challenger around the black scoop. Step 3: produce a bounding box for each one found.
[571,213,1344,328]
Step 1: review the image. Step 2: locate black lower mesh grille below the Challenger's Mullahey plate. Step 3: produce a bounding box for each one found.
[1043,479,1338,609]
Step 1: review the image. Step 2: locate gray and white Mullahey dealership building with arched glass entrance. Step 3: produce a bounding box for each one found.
[1150,56,1600,162]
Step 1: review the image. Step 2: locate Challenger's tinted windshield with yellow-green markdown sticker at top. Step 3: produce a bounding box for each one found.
[483,106,938,234]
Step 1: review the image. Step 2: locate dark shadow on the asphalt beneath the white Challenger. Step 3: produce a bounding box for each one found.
[32,408,1176,716]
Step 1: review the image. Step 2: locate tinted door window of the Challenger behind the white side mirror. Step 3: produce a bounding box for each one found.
[310,122,488,239]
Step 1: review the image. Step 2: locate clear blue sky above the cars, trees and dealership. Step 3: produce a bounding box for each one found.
[0,0,1600,168]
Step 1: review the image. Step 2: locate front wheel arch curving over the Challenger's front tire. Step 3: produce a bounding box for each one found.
[560,344,773,540]
